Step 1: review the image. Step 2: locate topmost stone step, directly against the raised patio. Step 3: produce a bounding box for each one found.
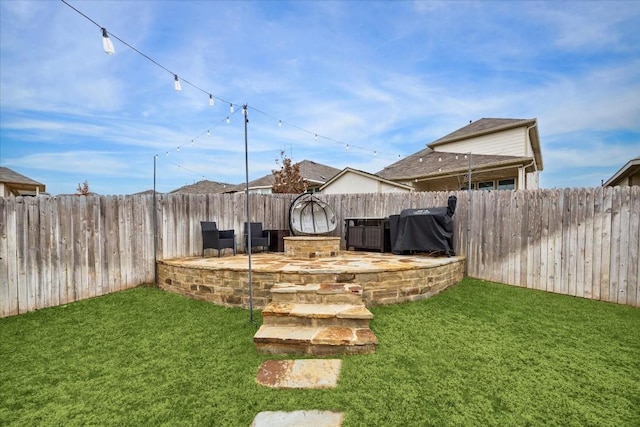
[271,283,362,304]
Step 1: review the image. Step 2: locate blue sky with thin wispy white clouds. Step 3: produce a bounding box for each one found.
[0,0,640,194]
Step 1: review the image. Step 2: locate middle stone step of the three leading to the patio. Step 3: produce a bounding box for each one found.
[262,302,373,328]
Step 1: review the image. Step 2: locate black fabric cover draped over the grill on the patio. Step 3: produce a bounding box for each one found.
[389,196,456,256]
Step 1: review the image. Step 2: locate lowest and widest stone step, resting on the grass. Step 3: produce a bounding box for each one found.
[253,325,378,356]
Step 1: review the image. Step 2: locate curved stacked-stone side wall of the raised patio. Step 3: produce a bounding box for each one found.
[158,258,465,309]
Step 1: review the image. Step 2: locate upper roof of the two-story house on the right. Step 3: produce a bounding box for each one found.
[427,118,543,170]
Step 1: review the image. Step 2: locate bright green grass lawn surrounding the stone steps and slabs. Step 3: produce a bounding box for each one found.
[0,279,640,426]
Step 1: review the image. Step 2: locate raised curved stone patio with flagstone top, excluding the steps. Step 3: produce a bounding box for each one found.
[158,251,465,309]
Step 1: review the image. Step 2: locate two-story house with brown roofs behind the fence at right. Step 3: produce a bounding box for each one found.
[376,118,543,191]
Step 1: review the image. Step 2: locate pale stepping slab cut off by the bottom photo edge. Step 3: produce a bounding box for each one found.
[251,410,344,427]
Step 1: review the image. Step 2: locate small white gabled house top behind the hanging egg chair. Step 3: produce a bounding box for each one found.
[319,168,412,194]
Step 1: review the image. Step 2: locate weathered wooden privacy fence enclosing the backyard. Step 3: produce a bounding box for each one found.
[0,187,640,317]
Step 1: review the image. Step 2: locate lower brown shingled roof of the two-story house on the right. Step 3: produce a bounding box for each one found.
[376,147,531,181]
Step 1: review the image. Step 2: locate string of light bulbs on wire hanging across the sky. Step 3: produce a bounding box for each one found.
[60,0,402,183]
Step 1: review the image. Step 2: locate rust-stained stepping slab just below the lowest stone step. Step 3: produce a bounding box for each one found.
[256,359,342,389]
